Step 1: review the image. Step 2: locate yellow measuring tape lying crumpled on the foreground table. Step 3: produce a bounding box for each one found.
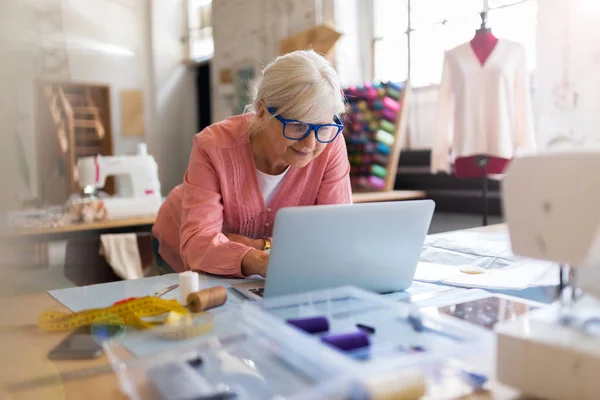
[38,296,190,332]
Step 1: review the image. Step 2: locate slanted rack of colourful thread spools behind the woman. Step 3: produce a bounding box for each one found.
[344,82,411,192]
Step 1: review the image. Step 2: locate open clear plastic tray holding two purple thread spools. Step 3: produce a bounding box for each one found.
[251,287,492,374]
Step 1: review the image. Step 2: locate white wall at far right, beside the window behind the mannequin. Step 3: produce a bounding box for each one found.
[534,0,600,148]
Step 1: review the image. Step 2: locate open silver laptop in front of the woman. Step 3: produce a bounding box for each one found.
[232,200,435,300]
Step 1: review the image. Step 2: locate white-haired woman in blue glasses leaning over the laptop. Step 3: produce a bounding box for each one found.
[153,51,352,277]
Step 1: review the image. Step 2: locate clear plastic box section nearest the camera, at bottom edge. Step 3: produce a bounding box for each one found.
[104,306,370,400]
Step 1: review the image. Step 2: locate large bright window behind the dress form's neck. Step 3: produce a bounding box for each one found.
[373,0,537,87]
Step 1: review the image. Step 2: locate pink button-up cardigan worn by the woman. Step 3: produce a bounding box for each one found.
[152,114,352,277]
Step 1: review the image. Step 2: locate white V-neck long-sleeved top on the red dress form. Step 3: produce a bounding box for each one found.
[431,39,536,173]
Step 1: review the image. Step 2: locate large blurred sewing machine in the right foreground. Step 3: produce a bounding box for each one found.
[496,150,600,400]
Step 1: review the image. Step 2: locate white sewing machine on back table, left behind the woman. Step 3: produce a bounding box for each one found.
[77,143,162,219]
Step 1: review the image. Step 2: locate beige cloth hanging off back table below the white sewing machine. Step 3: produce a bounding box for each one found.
[100,233,144,279]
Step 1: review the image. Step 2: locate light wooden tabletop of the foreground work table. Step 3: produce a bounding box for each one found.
[0,225,518,400]
